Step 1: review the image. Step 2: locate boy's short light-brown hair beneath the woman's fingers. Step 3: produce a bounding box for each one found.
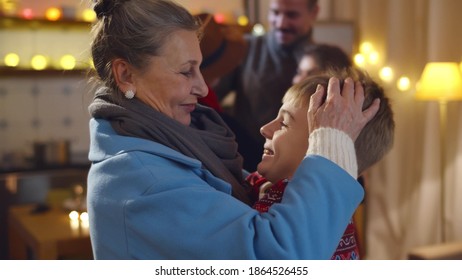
[283,68,395,174]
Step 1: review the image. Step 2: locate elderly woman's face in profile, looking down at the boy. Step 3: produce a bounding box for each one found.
[133,30,208,125]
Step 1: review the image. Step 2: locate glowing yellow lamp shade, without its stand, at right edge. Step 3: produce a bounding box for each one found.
[415,62,462,100]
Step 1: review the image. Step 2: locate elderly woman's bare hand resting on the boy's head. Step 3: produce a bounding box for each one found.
[308,77,380,142]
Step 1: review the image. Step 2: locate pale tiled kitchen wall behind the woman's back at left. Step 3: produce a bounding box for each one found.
[0,75,93,167]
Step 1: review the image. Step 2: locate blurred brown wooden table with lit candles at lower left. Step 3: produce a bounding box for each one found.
[9,206,92,260]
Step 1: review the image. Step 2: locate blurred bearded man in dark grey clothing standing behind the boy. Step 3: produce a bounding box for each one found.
[212,0,319,171]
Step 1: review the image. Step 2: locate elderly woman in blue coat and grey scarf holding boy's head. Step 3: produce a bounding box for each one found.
[88,0,378,259]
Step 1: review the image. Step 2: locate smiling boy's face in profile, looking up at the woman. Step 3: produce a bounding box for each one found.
[257,99,308,183]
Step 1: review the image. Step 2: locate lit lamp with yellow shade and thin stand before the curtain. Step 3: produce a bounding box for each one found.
[415,62,462,243]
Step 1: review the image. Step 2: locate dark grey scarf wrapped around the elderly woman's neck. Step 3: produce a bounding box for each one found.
[89,88,250,204]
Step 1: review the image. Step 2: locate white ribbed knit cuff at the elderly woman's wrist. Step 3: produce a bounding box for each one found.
[306,127,358,179]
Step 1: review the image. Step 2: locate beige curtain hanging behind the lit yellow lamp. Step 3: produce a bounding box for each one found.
[328,0,462,259]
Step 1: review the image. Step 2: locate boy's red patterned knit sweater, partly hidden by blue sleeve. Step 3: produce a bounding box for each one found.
[246,172,360,260]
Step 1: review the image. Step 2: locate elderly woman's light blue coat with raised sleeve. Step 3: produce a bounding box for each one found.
[88,119,364,259]
